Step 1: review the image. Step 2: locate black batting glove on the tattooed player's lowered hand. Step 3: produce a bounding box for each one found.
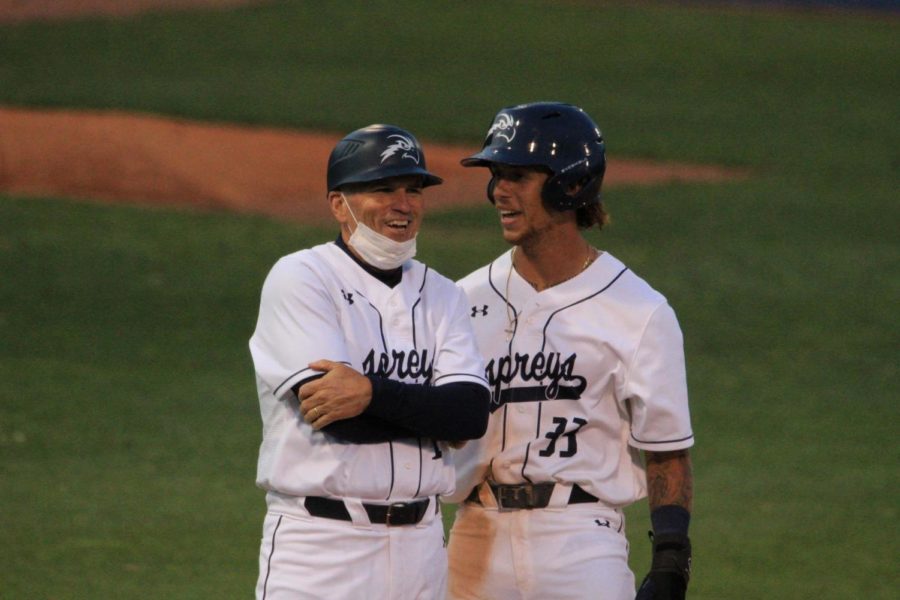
[635,532,691,600]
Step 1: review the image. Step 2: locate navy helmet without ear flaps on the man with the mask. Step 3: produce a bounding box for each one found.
[328,125,444,191]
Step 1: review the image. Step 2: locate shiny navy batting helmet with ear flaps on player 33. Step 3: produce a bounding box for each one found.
[461,102,606,210]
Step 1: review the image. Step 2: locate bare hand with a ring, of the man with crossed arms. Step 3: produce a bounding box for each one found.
[297,360,372,430]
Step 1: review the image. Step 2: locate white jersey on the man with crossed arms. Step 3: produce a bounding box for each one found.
[250,243,484,502]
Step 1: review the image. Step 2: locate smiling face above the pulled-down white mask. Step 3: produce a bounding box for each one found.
[328,175,425,242]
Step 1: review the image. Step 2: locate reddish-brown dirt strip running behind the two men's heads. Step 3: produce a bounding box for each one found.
[0,108,741,220]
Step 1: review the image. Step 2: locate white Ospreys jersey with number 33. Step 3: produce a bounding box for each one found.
[450,252,693,508]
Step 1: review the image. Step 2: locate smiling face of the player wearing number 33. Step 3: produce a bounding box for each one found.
[490,163,571,245]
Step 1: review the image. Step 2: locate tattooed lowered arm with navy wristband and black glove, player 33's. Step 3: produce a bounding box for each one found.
[636,449,694,600]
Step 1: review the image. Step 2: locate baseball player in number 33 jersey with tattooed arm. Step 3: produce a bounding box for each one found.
[448,102,694,600]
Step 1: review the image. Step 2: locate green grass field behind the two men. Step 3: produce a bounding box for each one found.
[0,1,900,600]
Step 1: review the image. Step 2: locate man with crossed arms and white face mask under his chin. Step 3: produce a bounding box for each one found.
[250,125,490,600]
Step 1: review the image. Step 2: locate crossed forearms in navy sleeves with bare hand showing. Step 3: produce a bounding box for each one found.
[298,361,490,443]
